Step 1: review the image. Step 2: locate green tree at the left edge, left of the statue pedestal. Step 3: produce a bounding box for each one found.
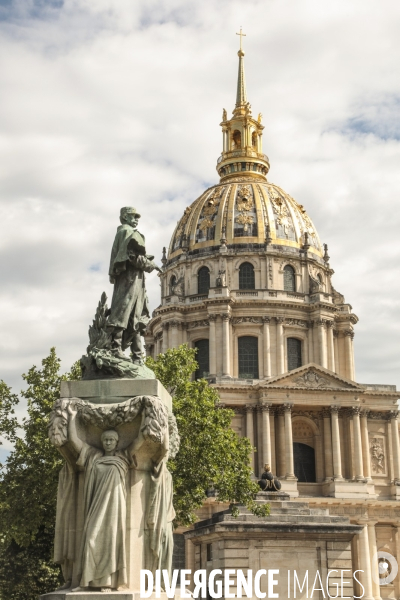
[0,348,80,600]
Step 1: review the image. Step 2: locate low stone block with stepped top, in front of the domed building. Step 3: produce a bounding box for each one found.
[184,492,362,599]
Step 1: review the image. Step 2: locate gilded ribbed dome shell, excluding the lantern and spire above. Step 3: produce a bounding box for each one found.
[168,175,323,259]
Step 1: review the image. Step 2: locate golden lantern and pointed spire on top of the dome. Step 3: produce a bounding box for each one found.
[217,28,269,182]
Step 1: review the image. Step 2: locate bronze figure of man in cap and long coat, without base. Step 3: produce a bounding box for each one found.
[107,206,160,364]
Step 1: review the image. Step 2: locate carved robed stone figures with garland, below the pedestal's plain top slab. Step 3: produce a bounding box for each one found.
[49,396,179,592]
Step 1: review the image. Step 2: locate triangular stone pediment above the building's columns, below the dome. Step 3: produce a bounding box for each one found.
[260,363,364,391]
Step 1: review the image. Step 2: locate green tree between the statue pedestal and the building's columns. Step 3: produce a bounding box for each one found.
[147,345,269,525]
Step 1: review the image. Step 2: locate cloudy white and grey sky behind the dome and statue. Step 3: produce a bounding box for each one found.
[0,0,400,436]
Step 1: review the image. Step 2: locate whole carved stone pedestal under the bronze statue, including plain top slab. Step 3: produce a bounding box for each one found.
[40,379,179,600]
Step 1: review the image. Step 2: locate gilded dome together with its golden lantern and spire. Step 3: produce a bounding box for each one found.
[168,34,323,260]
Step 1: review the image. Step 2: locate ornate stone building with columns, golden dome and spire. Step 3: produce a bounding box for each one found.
[146,39,400,600]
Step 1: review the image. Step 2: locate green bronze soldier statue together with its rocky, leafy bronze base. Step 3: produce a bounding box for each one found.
[81,206,161,379]
